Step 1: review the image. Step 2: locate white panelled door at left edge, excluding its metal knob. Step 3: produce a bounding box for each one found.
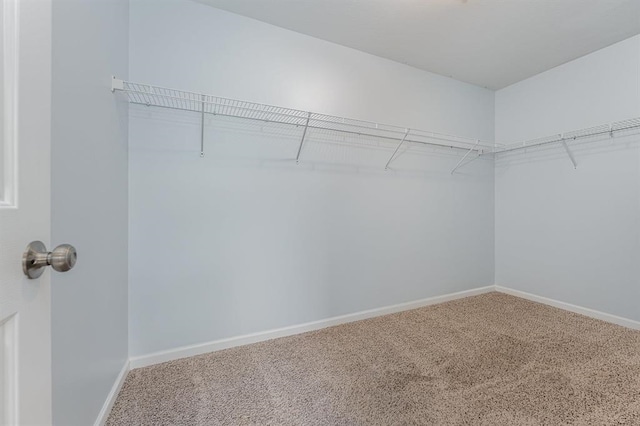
[0,0,51,425]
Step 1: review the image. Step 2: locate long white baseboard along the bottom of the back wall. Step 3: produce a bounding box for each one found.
[129,285,495,369]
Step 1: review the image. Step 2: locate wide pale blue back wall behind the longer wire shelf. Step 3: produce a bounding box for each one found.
[129,0,494,356]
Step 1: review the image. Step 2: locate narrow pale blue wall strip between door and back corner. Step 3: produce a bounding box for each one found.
[51,0,129,426]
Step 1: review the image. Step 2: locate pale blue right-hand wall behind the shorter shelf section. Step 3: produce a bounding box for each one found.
[495,36,640,320]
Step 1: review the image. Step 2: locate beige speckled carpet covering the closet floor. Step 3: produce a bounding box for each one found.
[107,293,640,426]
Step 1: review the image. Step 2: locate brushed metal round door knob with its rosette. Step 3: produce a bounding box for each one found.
[22,241,78,279]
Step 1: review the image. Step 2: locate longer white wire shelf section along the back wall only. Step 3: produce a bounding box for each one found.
[112,78,496,172]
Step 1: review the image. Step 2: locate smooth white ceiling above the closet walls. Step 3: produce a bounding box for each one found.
[192,0,640,89]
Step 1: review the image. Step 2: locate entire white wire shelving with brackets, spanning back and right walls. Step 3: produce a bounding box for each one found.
[112,77,640,173]
